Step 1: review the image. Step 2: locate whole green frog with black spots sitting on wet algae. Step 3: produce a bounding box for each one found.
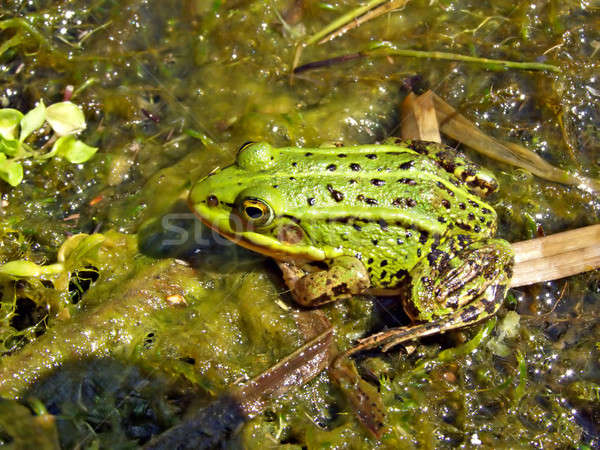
[189,138,514,434]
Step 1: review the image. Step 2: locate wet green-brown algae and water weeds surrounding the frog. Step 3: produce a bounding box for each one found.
[0,0,600,449]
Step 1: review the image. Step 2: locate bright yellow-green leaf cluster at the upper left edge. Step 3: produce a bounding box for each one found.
[0,101,98,186]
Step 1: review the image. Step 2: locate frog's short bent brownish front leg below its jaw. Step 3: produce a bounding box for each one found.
[277,256,371,306]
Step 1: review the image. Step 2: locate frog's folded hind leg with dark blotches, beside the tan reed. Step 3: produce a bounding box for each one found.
[347,236,514,354]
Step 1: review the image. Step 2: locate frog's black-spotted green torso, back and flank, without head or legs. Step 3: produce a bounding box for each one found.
[267,145,496,288]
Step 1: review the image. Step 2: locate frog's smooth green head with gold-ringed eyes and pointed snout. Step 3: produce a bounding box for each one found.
[189,143,328,261]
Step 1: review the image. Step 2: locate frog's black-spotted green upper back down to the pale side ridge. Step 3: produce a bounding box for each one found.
[267,145,496,236]
